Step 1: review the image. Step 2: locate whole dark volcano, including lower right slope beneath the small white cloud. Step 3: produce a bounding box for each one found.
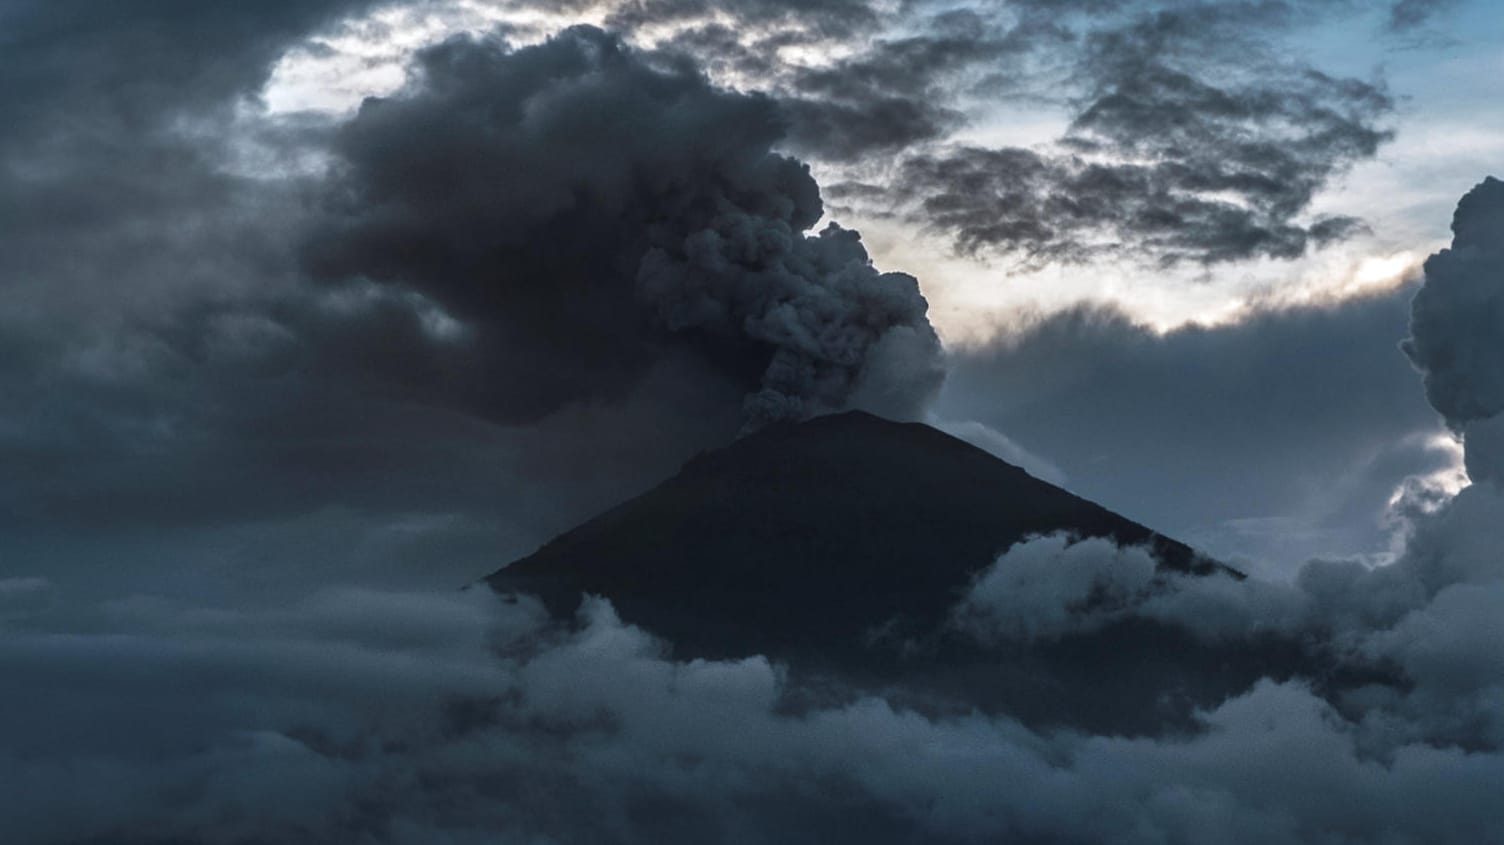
[487,412,1361,734]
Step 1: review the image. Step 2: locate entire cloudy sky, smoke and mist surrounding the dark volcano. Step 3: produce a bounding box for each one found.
[0,0,1504,843]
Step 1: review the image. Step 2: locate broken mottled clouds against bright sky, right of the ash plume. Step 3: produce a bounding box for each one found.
[565,0,1394,265]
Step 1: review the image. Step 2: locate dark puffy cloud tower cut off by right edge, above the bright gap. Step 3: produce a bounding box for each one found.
[1403,176,1504,481]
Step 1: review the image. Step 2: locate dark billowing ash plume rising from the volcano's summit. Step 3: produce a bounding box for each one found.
[305,27,943,426]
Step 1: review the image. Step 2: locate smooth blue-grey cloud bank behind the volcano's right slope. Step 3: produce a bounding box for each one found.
[937,286,1448,564]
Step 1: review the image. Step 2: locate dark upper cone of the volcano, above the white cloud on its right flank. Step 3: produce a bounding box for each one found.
[490,412,1209,654]
